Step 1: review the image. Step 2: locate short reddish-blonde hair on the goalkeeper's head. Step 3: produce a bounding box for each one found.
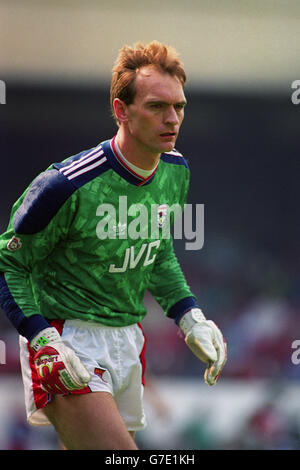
[110,41,186,121]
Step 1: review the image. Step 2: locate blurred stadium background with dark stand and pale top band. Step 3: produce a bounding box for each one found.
[0,0,300,449]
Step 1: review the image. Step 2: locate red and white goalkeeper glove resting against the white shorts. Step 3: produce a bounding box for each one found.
[29,327,91,394]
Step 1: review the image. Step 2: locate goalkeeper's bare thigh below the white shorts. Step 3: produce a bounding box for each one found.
[43,392,137,450]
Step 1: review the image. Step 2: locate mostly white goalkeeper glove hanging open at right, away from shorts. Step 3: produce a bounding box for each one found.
[179,308,227,385]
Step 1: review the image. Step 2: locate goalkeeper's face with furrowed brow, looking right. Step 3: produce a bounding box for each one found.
[123,66,186,154]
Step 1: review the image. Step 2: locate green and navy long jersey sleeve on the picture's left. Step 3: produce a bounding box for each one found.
[0,170,78,339]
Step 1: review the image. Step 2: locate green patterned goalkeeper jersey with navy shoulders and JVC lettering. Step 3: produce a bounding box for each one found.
[0,138,196,337]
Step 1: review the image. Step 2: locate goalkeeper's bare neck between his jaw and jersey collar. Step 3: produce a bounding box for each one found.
[116,128,160,170]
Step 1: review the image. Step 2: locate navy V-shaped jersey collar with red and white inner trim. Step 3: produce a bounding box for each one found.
[102,136,158,186]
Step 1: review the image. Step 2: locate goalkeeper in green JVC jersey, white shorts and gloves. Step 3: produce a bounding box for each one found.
[0,41,226,450]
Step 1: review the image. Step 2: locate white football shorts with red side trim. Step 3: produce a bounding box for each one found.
[20,320,146,431]
